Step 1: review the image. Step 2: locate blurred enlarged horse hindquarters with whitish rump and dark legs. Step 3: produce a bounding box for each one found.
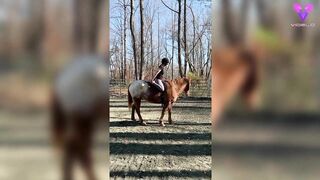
[50,56,108,180]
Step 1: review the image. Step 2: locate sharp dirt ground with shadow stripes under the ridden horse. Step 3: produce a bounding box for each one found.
[110,99,211,179]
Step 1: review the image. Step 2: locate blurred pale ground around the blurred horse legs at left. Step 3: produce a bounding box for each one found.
[0,110,108,180]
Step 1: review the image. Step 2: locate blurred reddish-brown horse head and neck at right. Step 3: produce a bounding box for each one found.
[211,46,260,124]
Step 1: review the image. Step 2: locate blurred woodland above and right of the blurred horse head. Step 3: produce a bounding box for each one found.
[212,0,320,112]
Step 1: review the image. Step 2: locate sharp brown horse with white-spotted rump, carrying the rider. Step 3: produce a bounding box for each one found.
[128,77,191,126]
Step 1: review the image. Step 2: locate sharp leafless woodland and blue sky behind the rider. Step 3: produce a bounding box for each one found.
[110,0,212,81]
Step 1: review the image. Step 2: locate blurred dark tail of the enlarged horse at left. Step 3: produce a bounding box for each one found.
[50,90,66,147]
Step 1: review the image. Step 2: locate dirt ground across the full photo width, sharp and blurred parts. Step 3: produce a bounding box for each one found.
[0,99,320,180]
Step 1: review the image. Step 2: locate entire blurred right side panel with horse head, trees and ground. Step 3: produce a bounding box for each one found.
[212,0,320,180]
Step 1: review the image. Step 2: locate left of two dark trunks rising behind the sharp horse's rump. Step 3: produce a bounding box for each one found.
[130,0,138,80]
